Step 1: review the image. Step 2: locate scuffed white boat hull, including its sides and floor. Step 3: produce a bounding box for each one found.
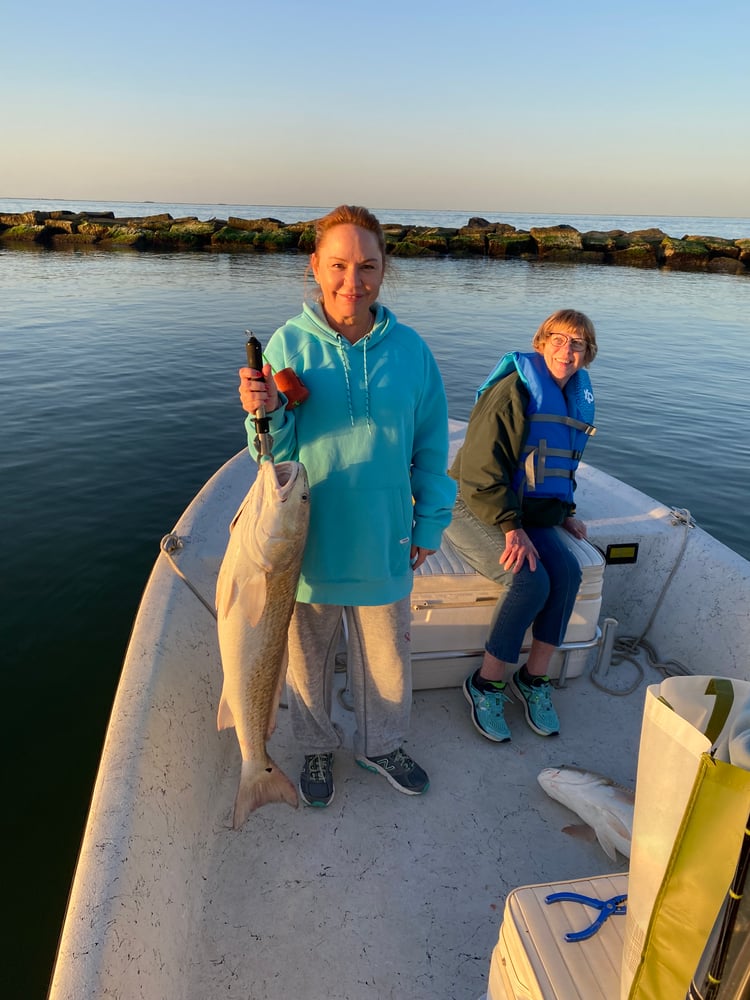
[50,424,750,1000]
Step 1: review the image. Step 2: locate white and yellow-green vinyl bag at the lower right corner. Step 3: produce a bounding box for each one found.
[620,677,750,1000]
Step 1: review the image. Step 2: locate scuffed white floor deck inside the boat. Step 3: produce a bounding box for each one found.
[184,656,642,1000]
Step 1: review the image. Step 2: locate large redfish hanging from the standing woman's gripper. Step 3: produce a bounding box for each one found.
[216,461,310,830]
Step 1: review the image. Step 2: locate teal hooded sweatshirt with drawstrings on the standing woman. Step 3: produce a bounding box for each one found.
[246,304,456,605]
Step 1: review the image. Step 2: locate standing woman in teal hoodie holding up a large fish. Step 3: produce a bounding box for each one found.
[240,205,456,806]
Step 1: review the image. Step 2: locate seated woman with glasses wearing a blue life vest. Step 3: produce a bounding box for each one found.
[446,309,597,743]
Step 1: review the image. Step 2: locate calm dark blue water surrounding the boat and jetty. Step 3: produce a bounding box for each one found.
[0,200,750,998]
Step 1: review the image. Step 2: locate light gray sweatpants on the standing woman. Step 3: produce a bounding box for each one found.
[287,597,411,757]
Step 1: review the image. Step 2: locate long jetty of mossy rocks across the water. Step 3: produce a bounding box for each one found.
[0,211,750,275]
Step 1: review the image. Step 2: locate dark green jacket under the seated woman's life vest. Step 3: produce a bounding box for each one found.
[450,372,575,532]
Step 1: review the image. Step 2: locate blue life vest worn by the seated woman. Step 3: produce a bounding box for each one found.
[477,351,596,503]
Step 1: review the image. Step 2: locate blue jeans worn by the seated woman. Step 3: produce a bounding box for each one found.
[445,495,581,663]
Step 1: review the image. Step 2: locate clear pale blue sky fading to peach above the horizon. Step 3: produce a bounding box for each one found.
[0,0,750,216]
